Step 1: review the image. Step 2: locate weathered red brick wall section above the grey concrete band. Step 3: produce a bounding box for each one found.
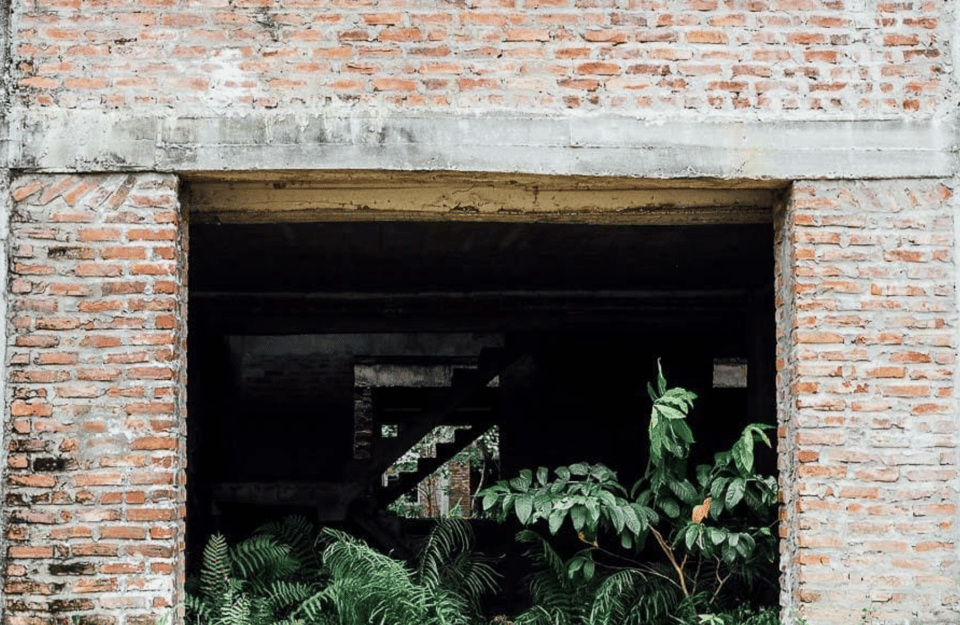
[13,0,951,118]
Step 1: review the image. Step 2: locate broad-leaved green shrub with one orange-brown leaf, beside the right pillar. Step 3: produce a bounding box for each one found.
[481,360,777,625]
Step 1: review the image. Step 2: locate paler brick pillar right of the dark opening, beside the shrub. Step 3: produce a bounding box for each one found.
[776,180,960,625]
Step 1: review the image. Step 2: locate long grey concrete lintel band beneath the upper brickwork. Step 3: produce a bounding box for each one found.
[11,110,957,180]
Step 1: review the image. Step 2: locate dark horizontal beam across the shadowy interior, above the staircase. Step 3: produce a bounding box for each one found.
[189,290,749,340]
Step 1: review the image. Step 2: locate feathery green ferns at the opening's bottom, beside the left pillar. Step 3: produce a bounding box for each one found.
[187,517,497,625]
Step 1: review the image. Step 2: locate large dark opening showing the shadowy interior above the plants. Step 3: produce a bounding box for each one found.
[188,211,777,616]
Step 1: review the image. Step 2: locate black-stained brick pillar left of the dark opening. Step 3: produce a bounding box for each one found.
[3,174,186,625]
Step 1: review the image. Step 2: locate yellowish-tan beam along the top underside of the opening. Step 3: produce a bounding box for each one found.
[185,171,782,225]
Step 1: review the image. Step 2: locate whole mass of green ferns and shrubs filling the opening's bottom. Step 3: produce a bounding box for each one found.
[187,360,779,625]
